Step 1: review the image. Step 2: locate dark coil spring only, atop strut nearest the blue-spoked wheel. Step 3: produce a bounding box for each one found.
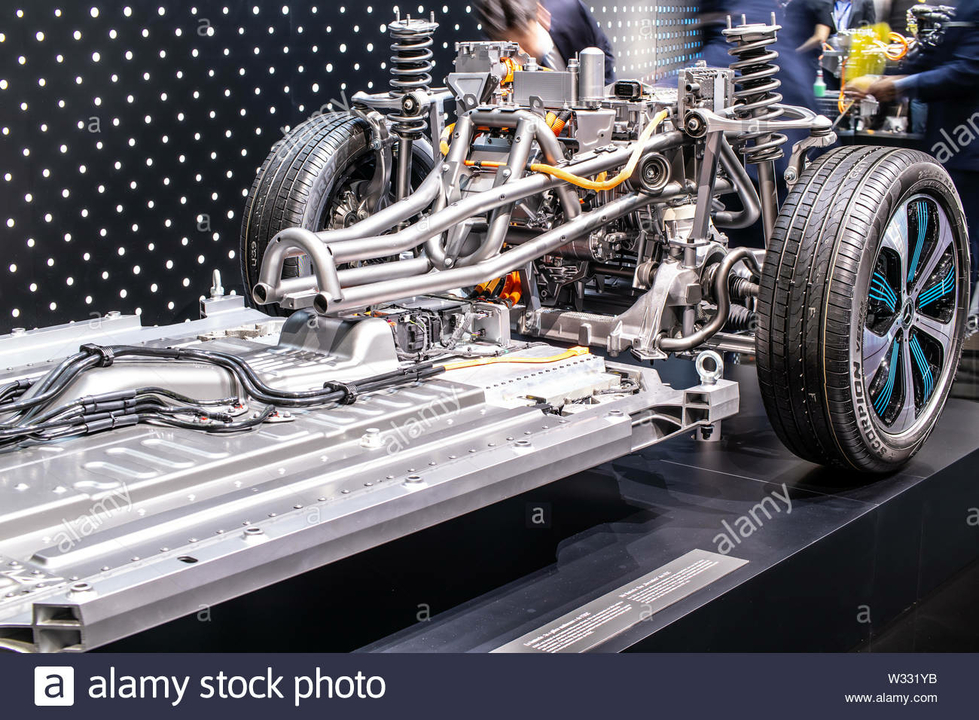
[723,16,788,164]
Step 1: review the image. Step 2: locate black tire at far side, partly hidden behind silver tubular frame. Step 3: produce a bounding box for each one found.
[240,113,433,315]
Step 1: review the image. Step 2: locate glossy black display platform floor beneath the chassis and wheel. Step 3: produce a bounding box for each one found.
[106,361,979,652]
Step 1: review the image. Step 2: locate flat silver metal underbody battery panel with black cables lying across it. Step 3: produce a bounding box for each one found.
[0,307,738,651]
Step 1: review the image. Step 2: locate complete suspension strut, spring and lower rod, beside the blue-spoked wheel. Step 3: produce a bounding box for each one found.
[722,13,787,245]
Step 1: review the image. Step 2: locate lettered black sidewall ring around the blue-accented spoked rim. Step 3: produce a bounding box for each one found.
[849,156,968,467]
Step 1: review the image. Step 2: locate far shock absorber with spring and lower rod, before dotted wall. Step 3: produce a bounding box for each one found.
[388,11,438,200]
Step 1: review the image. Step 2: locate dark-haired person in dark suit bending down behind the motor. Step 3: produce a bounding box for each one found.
[476,0,615,85]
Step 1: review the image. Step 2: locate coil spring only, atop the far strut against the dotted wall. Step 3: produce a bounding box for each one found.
[388,17,438,140]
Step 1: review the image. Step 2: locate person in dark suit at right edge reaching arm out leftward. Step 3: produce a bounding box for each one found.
[847,0,979,291]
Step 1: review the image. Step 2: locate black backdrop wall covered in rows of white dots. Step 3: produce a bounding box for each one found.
[0,0,699,332]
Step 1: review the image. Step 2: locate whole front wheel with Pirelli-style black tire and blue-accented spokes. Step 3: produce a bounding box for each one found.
[756,146,969,473]
